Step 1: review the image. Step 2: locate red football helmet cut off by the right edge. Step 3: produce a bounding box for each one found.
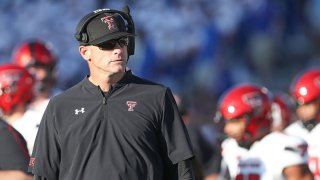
[290,69,320,104]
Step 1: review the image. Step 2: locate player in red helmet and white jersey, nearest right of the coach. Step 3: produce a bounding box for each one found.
[218,84,312,180]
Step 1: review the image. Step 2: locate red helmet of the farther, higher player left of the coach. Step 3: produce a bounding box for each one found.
[13,40,57,69]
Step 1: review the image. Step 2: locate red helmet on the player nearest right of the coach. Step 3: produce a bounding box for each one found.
[219,84,271,139]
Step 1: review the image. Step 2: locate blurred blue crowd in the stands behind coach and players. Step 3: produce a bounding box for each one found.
[0,0,320,121]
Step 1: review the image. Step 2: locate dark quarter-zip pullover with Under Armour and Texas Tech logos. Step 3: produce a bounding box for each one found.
[29,71,193,180]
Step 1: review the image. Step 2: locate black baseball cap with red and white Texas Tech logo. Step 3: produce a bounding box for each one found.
[78,13,134,45]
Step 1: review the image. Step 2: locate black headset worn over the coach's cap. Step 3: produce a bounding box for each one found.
[74,6,135,56]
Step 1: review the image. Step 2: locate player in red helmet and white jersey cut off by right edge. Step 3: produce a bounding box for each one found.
[285,68,320,179]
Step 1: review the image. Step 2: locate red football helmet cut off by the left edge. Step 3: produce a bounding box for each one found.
[0,64,34,114]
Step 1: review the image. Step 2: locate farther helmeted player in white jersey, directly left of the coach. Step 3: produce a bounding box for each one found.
[12,39,57,153]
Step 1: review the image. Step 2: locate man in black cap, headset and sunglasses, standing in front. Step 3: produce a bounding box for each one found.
[30,6,193,180]
